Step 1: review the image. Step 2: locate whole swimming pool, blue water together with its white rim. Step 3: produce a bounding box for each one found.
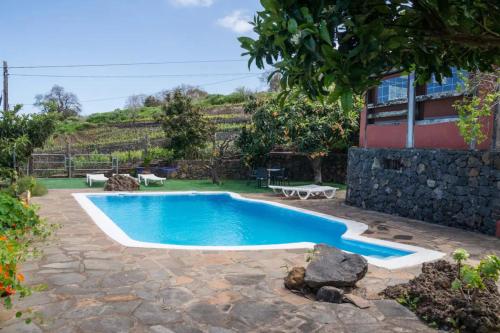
[74,192,441,268]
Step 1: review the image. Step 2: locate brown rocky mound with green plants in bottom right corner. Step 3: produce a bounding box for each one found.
[382,249,500,333]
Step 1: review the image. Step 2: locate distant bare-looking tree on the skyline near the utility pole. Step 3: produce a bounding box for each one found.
[34,84,82,119]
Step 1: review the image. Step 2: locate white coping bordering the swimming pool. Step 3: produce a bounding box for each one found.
[72,191,445,269]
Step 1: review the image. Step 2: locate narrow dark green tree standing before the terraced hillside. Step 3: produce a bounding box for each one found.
[162,89,209,158]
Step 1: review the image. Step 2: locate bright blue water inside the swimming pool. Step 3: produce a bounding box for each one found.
[88,193,412,258]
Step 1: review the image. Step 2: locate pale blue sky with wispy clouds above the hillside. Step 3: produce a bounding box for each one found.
[0,0,266,115]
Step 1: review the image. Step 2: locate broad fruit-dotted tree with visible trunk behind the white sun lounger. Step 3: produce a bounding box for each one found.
[238,91,361,184]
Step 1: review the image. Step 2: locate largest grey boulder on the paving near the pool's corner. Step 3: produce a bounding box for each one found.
[304,244,368,290]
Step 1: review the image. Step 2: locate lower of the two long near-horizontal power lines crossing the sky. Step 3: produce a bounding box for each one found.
[9,73,262,79]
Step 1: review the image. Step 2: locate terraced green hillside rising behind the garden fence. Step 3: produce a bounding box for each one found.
[37,92,262,153]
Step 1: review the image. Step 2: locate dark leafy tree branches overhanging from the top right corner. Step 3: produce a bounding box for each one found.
[239,0,500,107]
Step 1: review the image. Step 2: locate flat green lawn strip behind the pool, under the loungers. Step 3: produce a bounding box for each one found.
[37,178,345,193]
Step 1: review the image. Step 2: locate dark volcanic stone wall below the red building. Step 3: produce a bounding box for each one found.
[346,148,500,235]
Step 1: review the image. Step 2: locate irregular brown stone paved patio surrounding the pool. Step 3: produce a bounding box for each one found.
[0,190,500,333]
